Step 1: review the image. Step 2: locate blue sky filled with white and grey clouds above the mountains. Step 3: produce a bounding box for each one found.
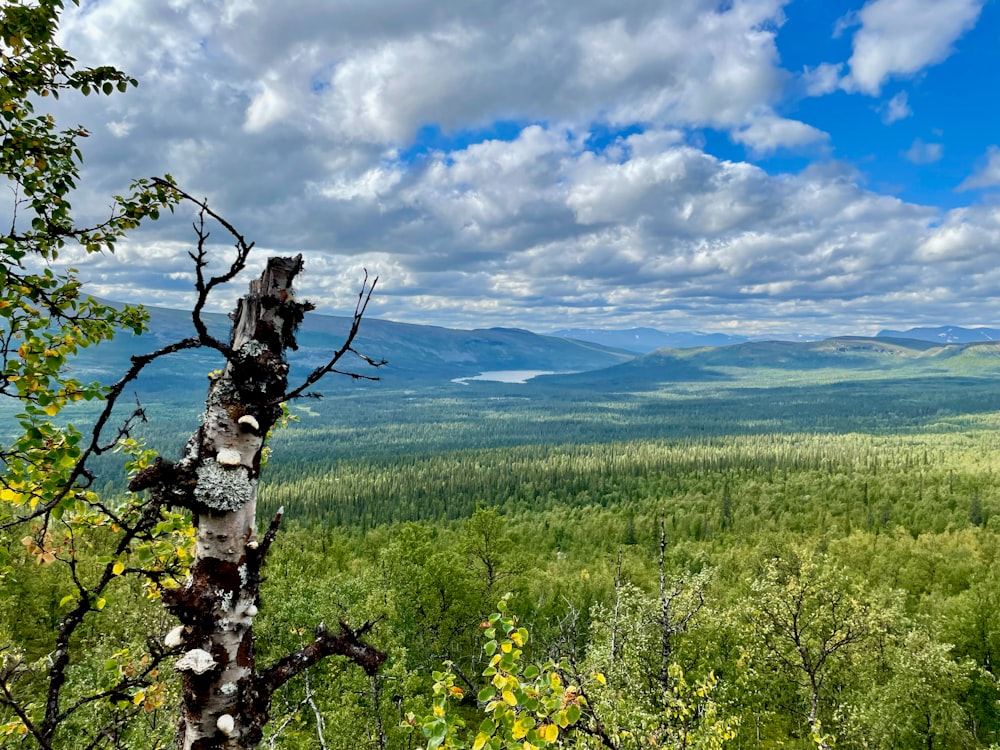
[39,0,1000,335]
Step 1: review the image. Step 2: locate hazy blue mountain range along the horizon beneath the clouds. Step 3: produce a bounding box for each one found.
[58,308,1000,402]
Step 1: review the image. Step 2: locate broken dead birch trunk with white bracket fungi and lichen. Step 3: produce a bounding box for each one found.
[130,256,385,750]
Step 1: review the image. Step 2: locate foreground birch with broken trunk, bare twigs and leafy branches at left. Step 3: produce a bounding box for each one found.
[0,0,385,750]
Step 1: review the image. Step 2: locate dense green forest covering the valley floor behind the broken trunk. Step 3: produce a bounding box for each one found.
[9,362,1000,748]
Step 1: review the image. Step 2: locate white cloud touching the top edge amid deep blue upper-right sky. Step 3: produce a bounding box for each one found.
[843,0,985,96]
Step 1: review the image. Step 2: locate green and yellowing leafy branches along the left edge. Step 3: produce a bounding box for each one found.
[0,0,184,747]
